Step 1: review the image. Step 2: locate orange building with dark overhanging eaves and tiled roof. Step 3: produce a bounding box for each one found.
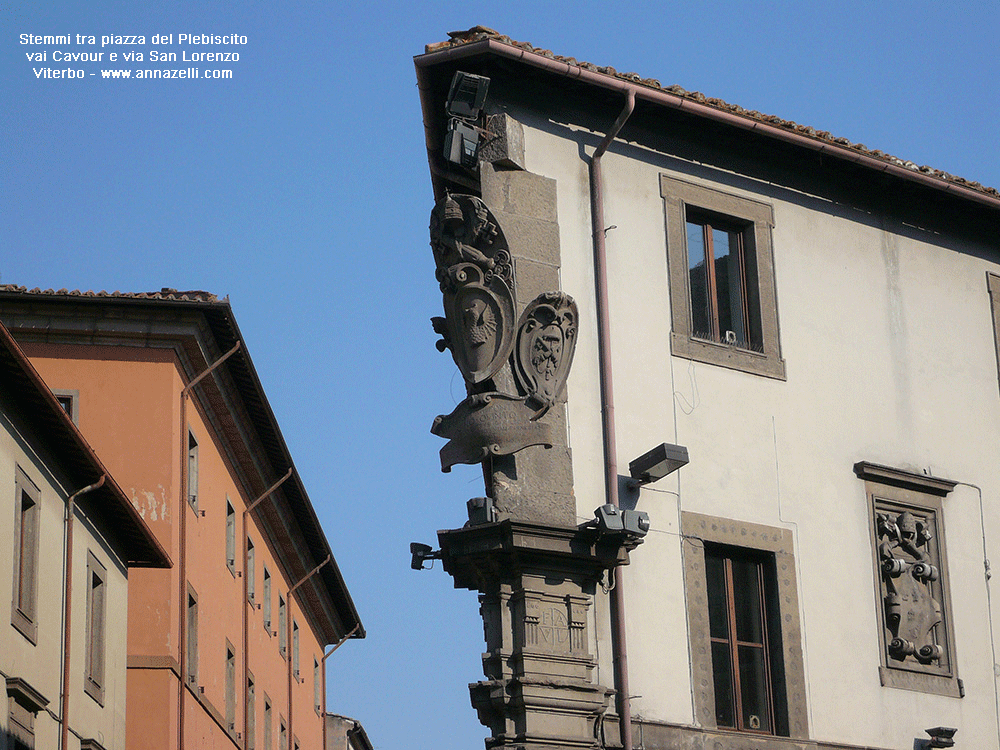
[0,285,365,750]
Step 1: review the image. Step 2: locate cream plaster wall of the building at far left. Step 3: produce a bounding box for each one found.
[0,414,128,750]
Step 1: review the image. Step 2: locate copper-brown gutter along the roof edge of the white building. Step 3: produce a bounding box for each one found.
[414,39,1000,210]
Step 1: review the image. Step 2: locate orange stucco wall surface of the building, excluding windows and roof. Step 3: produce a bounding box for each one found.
[23,344,323,750]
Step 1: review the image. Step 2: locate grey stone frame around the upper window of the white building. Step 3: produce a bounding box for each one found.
[660,174,786,380]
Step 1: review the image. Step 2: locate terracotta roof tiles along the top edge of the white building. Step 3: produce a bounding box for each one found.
[425,26,1000,198]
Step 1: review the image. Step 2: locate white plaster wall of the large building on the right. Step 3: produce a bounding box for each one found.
[519,112,1000,747]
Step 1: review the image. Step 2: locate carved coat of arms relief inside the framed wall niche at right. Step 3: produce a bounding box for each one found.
[876,511,943,665]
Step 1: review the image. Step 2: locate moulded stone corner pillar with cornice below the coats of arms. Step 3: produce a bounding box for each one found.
[438,519,628,750]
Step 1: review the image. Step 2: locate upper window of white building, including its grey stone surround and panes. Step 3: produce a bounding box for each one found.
[660,175,785,380]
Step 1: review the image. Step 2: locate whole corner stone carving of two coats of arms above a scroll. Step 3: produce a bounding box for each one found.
[430,194,579,471]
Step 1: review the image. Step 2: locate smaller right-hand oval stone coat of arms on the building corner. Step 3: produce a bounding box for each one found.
[514,292,579,419]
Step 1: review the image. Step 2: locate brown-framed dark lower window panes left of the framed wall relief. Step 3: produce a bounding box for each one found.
[705,544,780,734]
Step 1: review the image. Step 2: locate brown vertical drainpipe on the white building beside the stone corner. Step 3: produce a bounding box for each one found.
[590,89,635,750]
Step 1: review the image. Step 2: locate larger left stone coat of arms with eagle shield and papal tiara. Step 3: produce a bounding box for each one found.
[430,194,516,385]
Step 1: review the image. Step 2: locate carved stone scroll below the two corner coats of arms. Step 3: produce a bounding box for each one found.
[431,393,552,471]
